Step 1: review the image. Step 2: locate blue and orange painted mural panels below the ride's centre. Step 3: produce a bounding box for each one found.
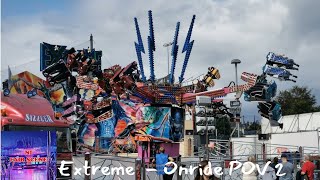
[78,100,184,149]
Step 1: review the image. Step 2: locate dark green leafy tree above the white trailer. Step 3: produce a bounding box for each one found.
[276,86,320,115]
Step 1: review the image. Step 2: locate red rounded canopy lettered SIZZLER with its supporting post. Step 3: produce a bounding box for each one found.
[1,93,73,179]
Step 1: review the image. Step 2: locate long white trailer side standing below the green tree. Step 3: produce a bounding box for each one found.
[231,112,320,160]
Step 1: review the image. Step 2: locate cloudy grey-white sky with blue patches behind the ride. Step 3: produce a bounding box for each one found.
[1,0,320,121]
